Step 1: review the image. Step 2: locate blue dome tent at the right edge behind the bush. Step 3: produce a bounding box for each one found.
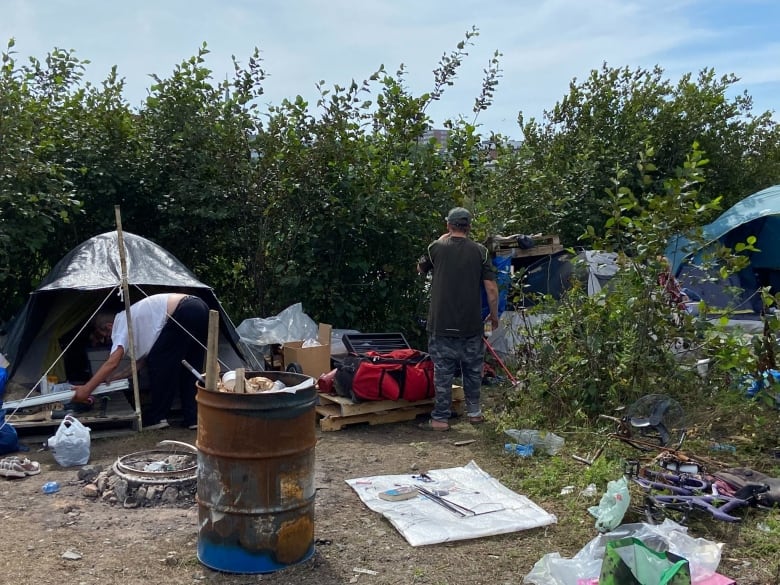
[666,185,780,311]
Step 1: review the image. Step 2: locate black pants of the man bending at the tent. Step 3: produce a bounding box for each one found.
[144,297,209,426]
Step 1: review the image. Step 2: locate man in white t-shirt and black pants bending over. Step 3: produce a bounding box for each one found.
[73,293,209,429]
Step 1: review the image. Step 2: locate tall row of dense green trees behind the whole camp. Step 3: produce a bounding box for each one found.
[0,28,780,358]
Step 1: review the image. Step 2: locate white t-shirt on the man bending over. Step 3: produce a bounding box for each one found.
[111,293,168,360]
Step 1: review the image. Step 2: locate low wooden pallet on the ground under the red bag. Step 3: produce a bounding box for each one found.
[316,386,464,431]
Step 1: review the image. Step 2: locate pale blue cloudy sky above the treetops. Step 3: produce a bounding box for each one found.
[0,0,780,138]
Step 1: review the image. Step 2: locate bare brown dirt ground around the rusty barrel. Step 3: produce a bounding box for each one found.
[0,410,770,585]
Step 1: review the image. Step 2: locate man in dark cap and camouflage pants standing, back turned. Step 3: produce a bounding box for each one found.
[417,207,498,431]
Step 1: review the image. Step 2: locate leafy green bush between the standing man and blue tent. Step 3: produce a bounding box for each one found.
[506,150,728,425]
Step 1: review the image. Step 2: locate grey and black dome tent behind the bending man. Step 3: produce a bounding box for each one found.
[0,231,245,387]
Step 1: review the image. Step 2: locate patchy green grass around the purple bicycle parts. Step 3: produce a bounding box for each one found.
[483,376,780,583]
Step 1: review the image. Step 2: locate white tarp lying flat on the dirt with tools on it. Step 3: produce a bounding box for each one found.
[347,461,558,546]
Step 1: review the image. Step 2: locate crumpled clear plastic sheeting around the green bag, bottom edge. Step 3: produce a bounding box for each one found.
[523,519,723,585]
